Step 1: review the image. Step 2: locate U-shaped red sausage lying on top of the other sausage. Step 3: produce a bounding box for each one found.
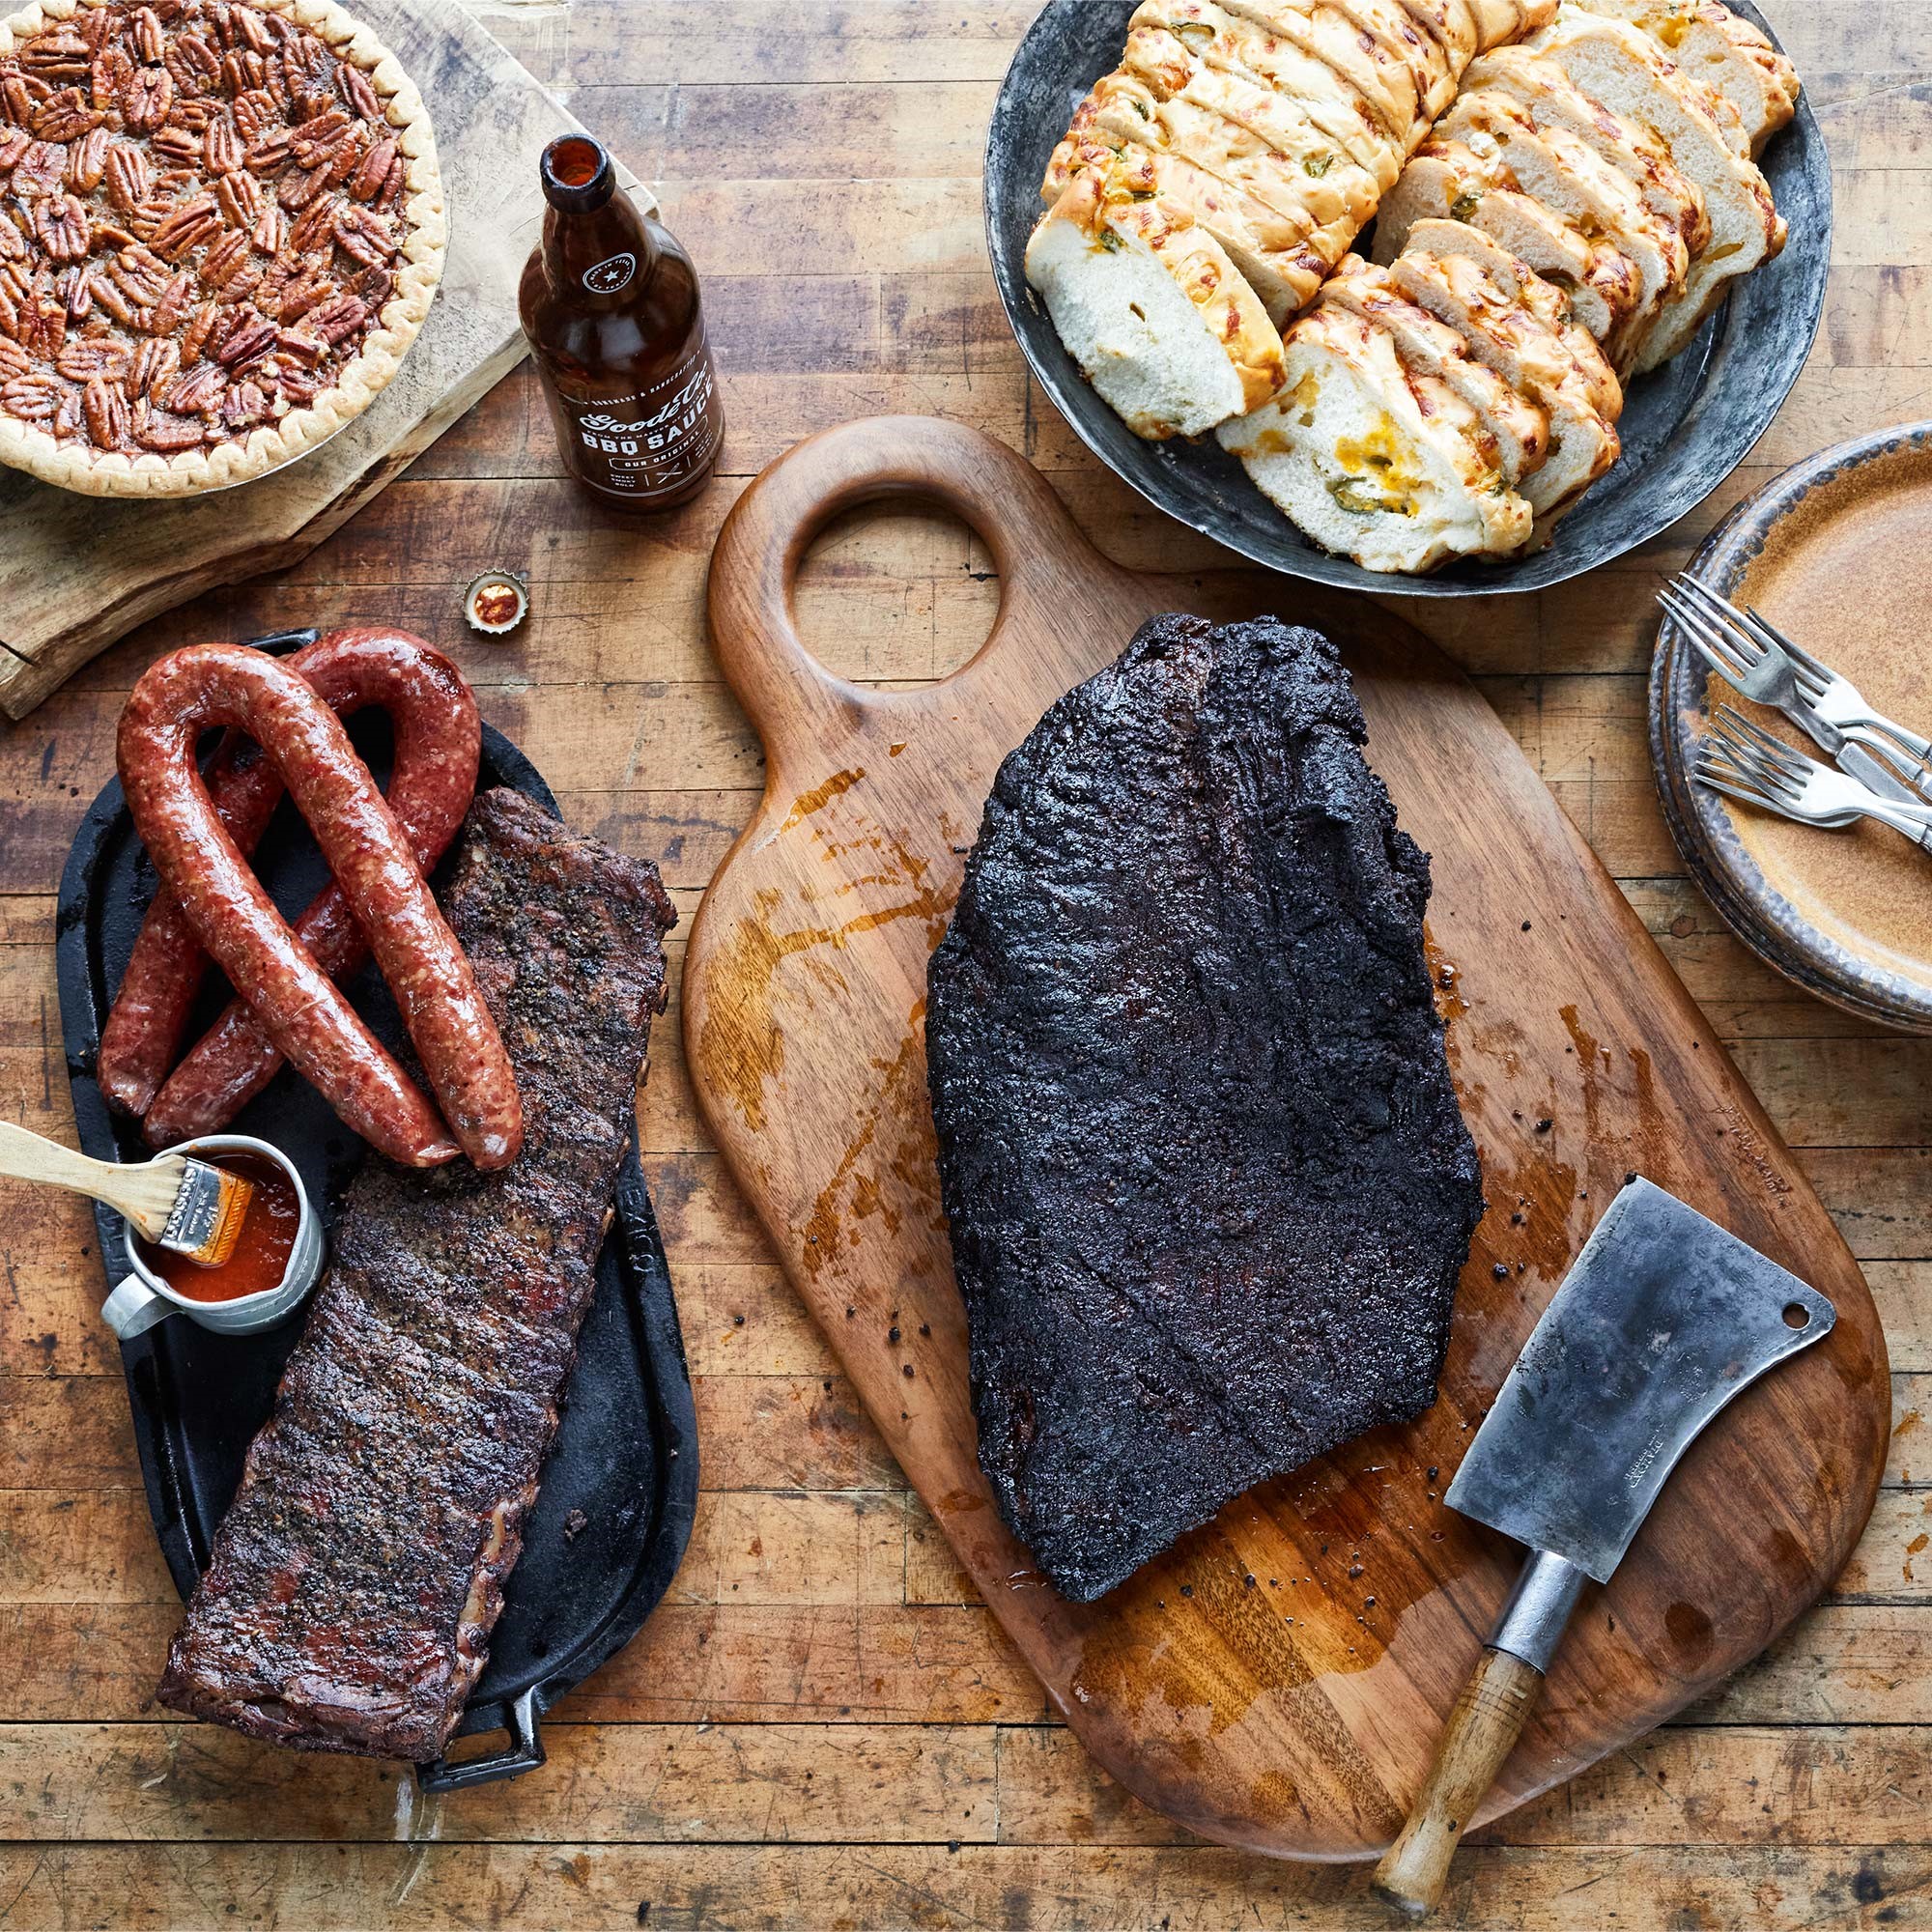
[116,643,524,1169]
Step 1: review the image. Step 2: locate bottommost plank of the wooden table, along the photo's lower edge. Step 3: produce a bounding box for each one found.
[0,1841,1932,1932]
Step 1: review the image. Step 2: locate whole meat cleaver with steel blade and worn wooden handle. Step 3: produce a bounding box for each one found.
[1376,1180,1837,1918]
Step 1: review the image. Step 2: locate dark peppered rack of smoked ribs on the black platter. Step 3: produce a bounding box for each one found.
[160,790,676,1760]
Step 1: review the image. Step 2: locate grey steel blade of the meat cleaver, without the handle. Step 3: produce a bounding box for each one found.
[1445,1179,1837,1582]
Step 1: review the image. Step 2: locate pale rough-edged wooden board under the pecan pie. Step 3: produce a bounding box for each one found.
[0,0,653,719]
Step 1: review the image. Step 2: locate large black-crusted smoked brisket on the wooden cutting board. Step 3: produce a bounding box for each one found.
[925,616,1482,1602]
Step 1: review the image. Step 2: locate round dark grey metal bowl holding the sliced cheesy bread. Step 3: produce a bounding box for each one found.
[985,0,1832,597]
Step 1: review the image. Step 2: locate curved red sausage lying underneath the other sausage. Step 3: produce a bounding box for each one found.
[142,630,483,1148]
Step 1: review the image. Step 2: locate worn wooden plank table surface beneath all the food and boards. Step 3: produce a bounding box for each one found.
[0,0,1932,1932]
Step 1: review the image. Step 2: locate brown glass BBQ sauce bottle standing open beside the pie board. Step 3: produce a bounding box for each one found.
[520,133,724,510]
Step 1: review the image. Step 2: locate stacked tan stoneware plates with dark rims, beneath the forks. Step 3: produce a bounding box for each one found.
[1650,423,1932,1034]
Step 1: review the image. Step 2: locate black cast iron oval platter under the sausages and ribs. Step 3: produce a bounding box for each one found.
[56,630,697,1791]
